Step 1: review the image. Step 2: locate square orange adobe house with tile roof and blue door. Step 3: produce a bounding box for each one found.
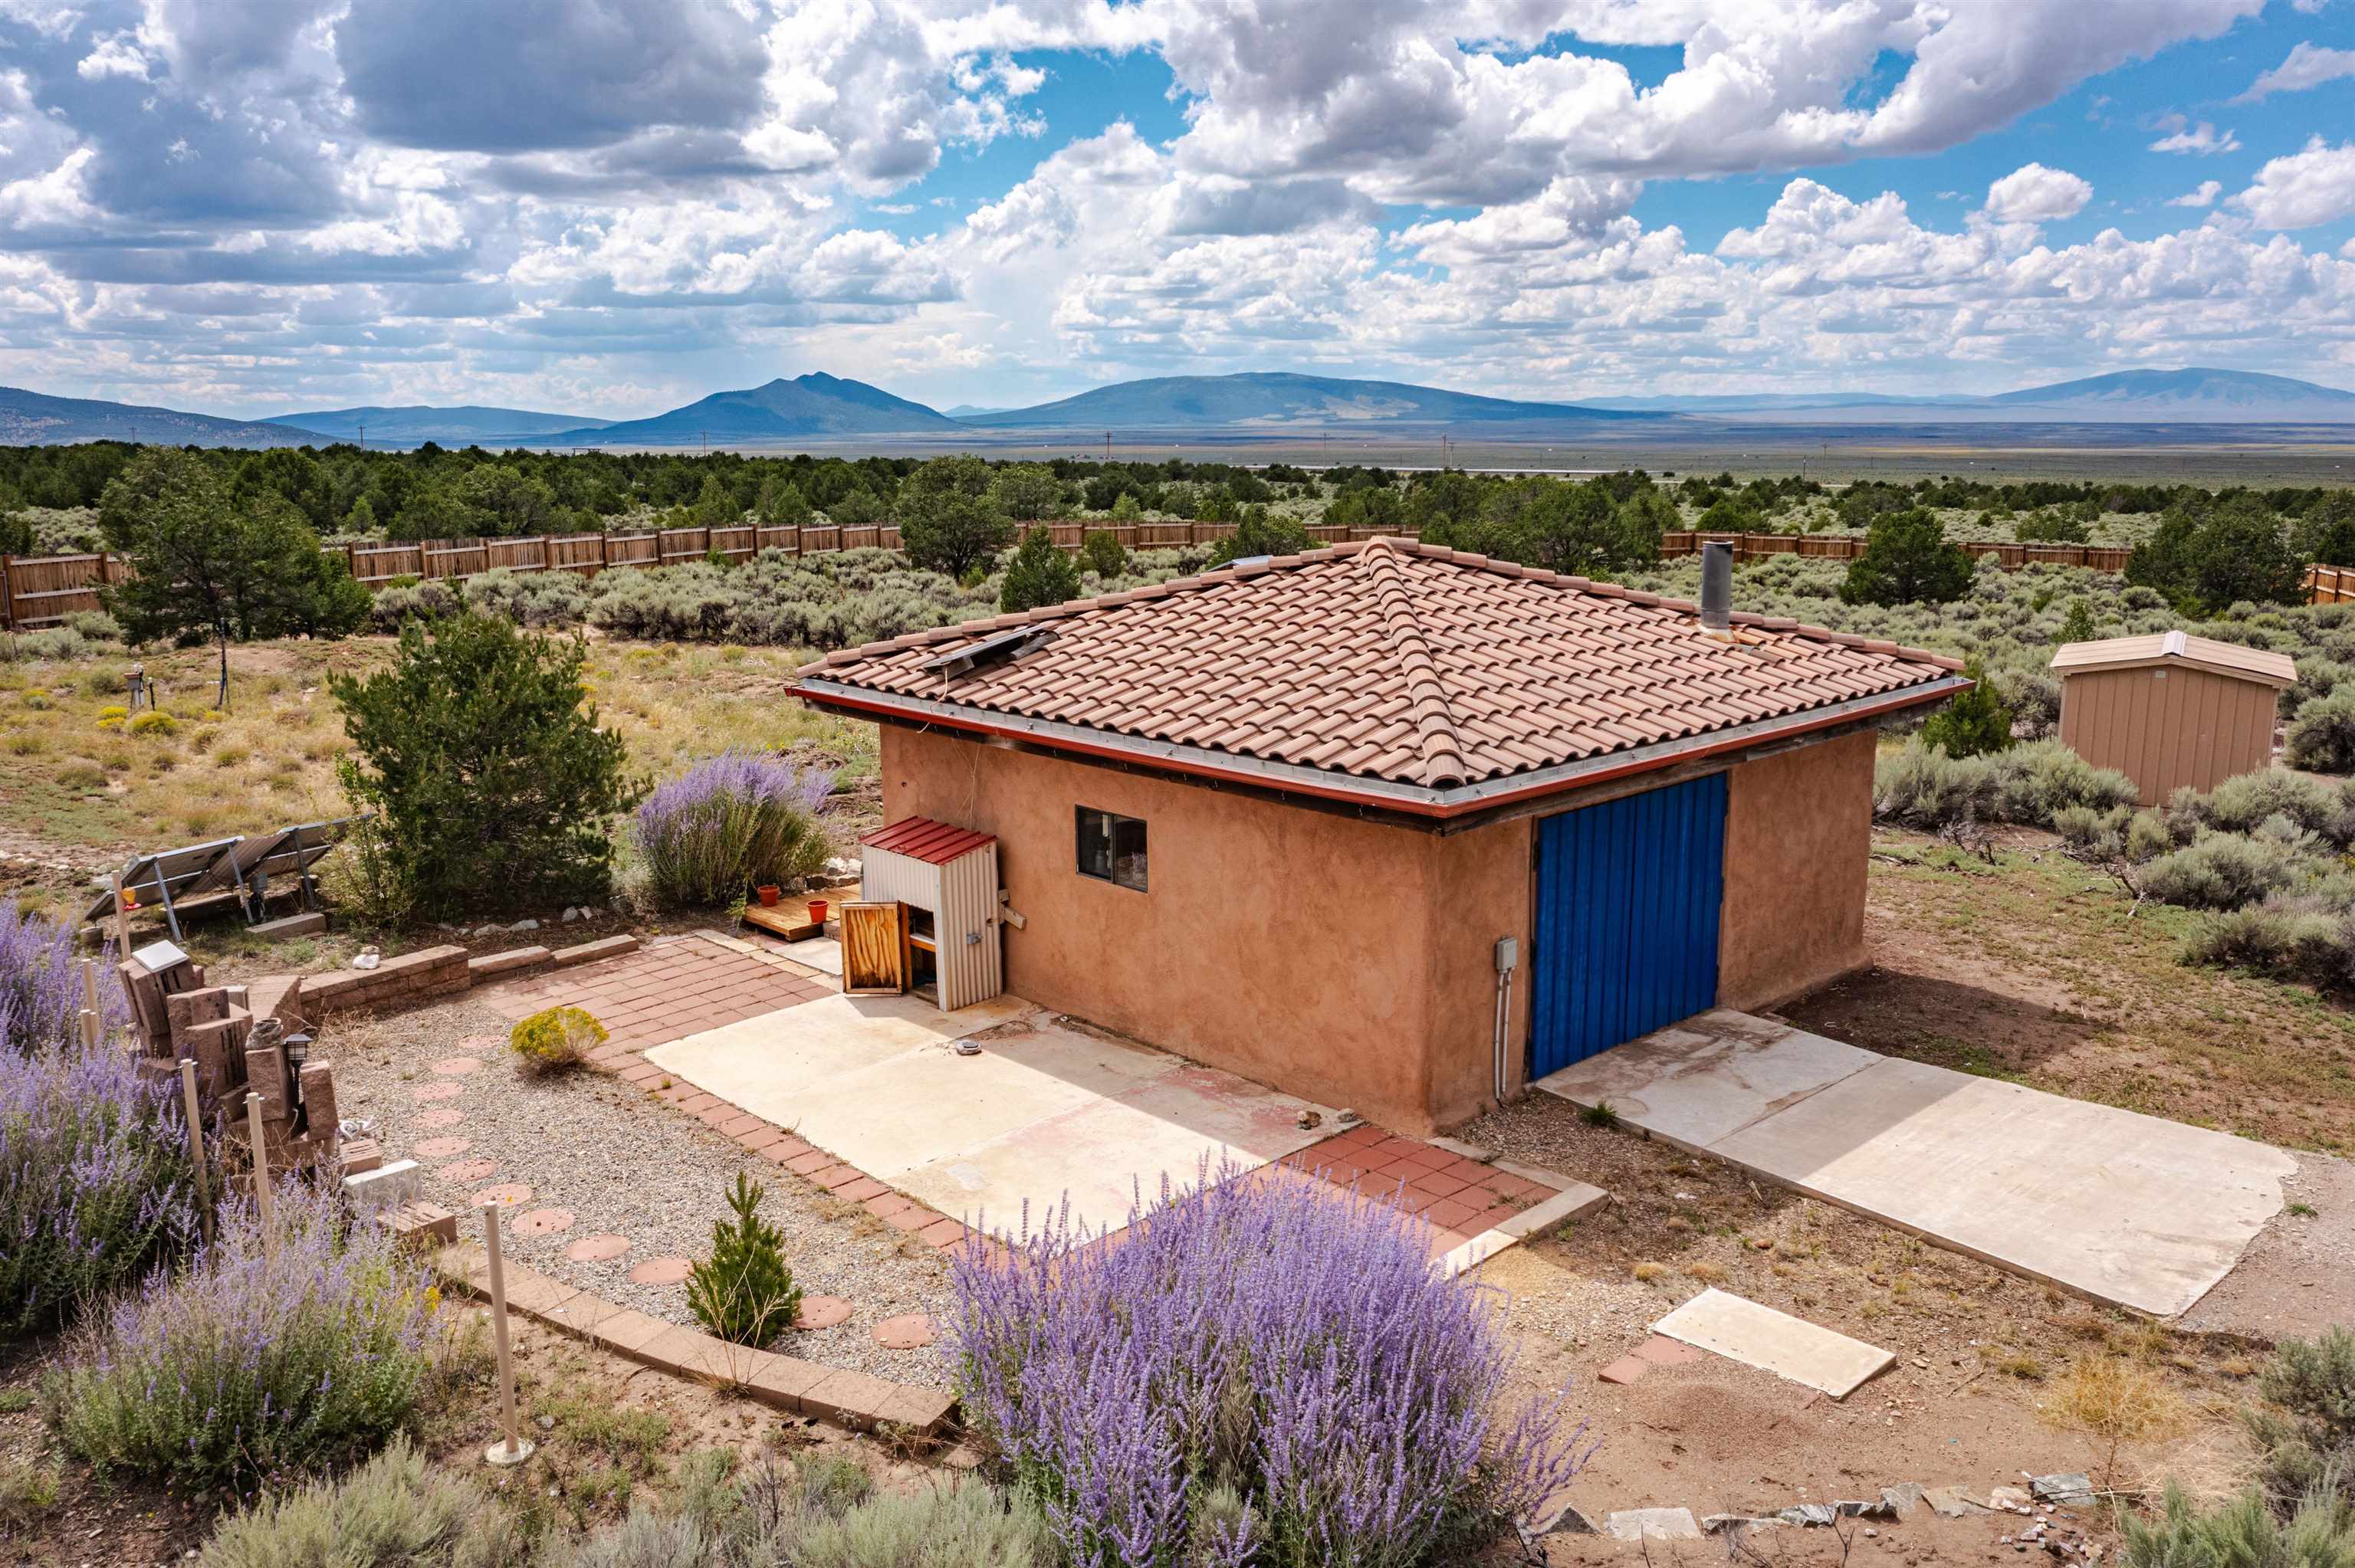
[796,540,1966,1133]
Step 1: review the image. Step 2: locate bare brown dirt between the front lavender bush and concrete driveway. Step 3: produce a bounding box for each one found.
[1460,1097,2256,1561]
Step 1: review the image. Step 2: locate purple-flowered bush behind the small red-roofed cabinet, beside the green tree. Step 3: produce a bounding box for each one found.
[631,751,833,904]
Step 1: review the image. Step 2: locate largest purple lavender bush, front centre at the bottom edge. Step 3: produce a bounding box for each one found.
[947,1166,1590,1568]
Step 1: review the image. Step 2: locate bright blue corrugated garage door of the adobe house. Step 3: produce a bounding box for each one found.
[1529,773,1726,1078]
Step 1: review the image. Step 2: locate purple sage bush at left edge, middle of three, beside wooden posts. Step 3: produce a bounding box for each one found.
[0,1036,195,1340]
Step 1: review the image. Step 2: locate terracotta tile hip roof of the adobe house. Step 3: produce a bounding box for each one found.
[800,540,1959,789]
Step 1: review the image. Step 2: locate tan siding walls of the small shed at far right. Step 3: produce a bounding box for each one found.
[2061,668,2275,805]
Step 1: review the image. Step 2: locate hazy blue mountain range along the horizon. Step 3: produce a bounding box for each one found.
[0,369,2355,450]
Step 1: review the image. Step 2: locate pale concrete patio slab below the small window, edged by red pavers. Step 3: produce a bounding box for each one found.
[645,996,1338,1229]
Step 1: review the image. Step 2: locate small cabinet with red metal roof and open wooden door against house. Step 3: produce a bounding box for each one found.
[843,817,1006,1012]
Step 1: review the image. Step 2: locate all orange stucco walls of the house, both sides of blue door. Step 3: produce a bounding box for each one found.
[883,725,1872,1133]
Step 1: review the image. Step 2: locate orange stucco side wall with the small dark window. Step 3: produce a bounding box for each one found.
[883,725,1488,1130]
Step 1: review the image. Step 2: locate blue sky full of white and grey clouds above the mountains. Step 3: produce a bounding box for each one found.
[0,0,2355,417]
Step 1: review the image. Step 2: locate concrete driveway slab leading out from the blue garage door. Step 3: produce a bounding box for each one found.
[1536,1015,2296,1316]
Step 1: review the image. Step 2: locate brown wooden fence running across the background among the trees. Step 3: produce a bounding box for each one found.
[0,520,2138,631]
